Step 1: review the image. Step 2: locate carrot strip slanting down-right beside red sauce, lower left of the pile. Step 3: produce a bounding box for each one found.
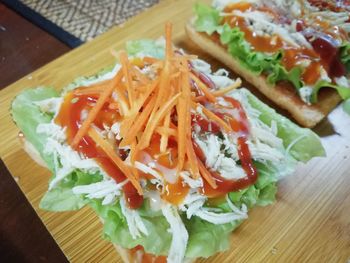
[88,127,142,195]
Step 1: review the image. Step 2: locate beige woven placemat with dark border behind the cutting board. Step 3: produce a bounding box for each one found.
[4,0,159,46]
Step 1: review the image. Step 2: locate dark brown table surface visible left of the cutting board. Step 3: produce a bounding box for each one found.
[0,1,70,263]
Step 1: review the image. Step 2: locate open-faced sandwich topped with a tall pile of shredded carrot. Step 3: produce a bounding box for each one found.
[11,25,324,262]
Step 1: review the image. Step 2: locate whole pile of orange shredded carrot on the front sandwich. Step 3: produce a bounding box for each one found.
[72,23,241,198]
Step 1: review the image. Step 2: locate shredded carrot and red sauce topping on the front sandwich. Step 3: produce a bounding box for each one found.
[56,25,246,209]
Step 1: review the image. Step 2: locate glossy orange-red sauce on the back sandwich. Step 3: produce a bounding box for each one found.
[223,3,347,85]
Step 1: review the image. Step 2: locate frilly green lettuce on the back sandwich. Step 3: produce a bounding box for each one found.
[194,4,350,103]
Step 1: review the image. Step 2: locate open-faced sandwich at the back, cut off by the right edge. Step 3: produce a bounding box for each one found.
[186,0,350,127]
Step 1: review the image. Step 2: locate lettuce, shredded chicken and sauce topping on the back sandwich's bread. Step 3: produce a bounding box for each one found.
[195,0,350,104]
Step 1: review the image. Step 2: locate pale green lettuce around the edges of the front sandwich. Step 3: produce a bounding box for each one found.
[13,41,324,258]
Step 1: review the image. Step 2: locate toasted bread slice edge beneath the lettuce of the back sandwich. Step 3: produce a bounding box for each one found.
[186,19,341,128]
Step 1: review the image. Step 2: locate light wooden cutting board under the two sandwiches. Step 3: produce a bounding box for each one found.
[0,0,350,262]
